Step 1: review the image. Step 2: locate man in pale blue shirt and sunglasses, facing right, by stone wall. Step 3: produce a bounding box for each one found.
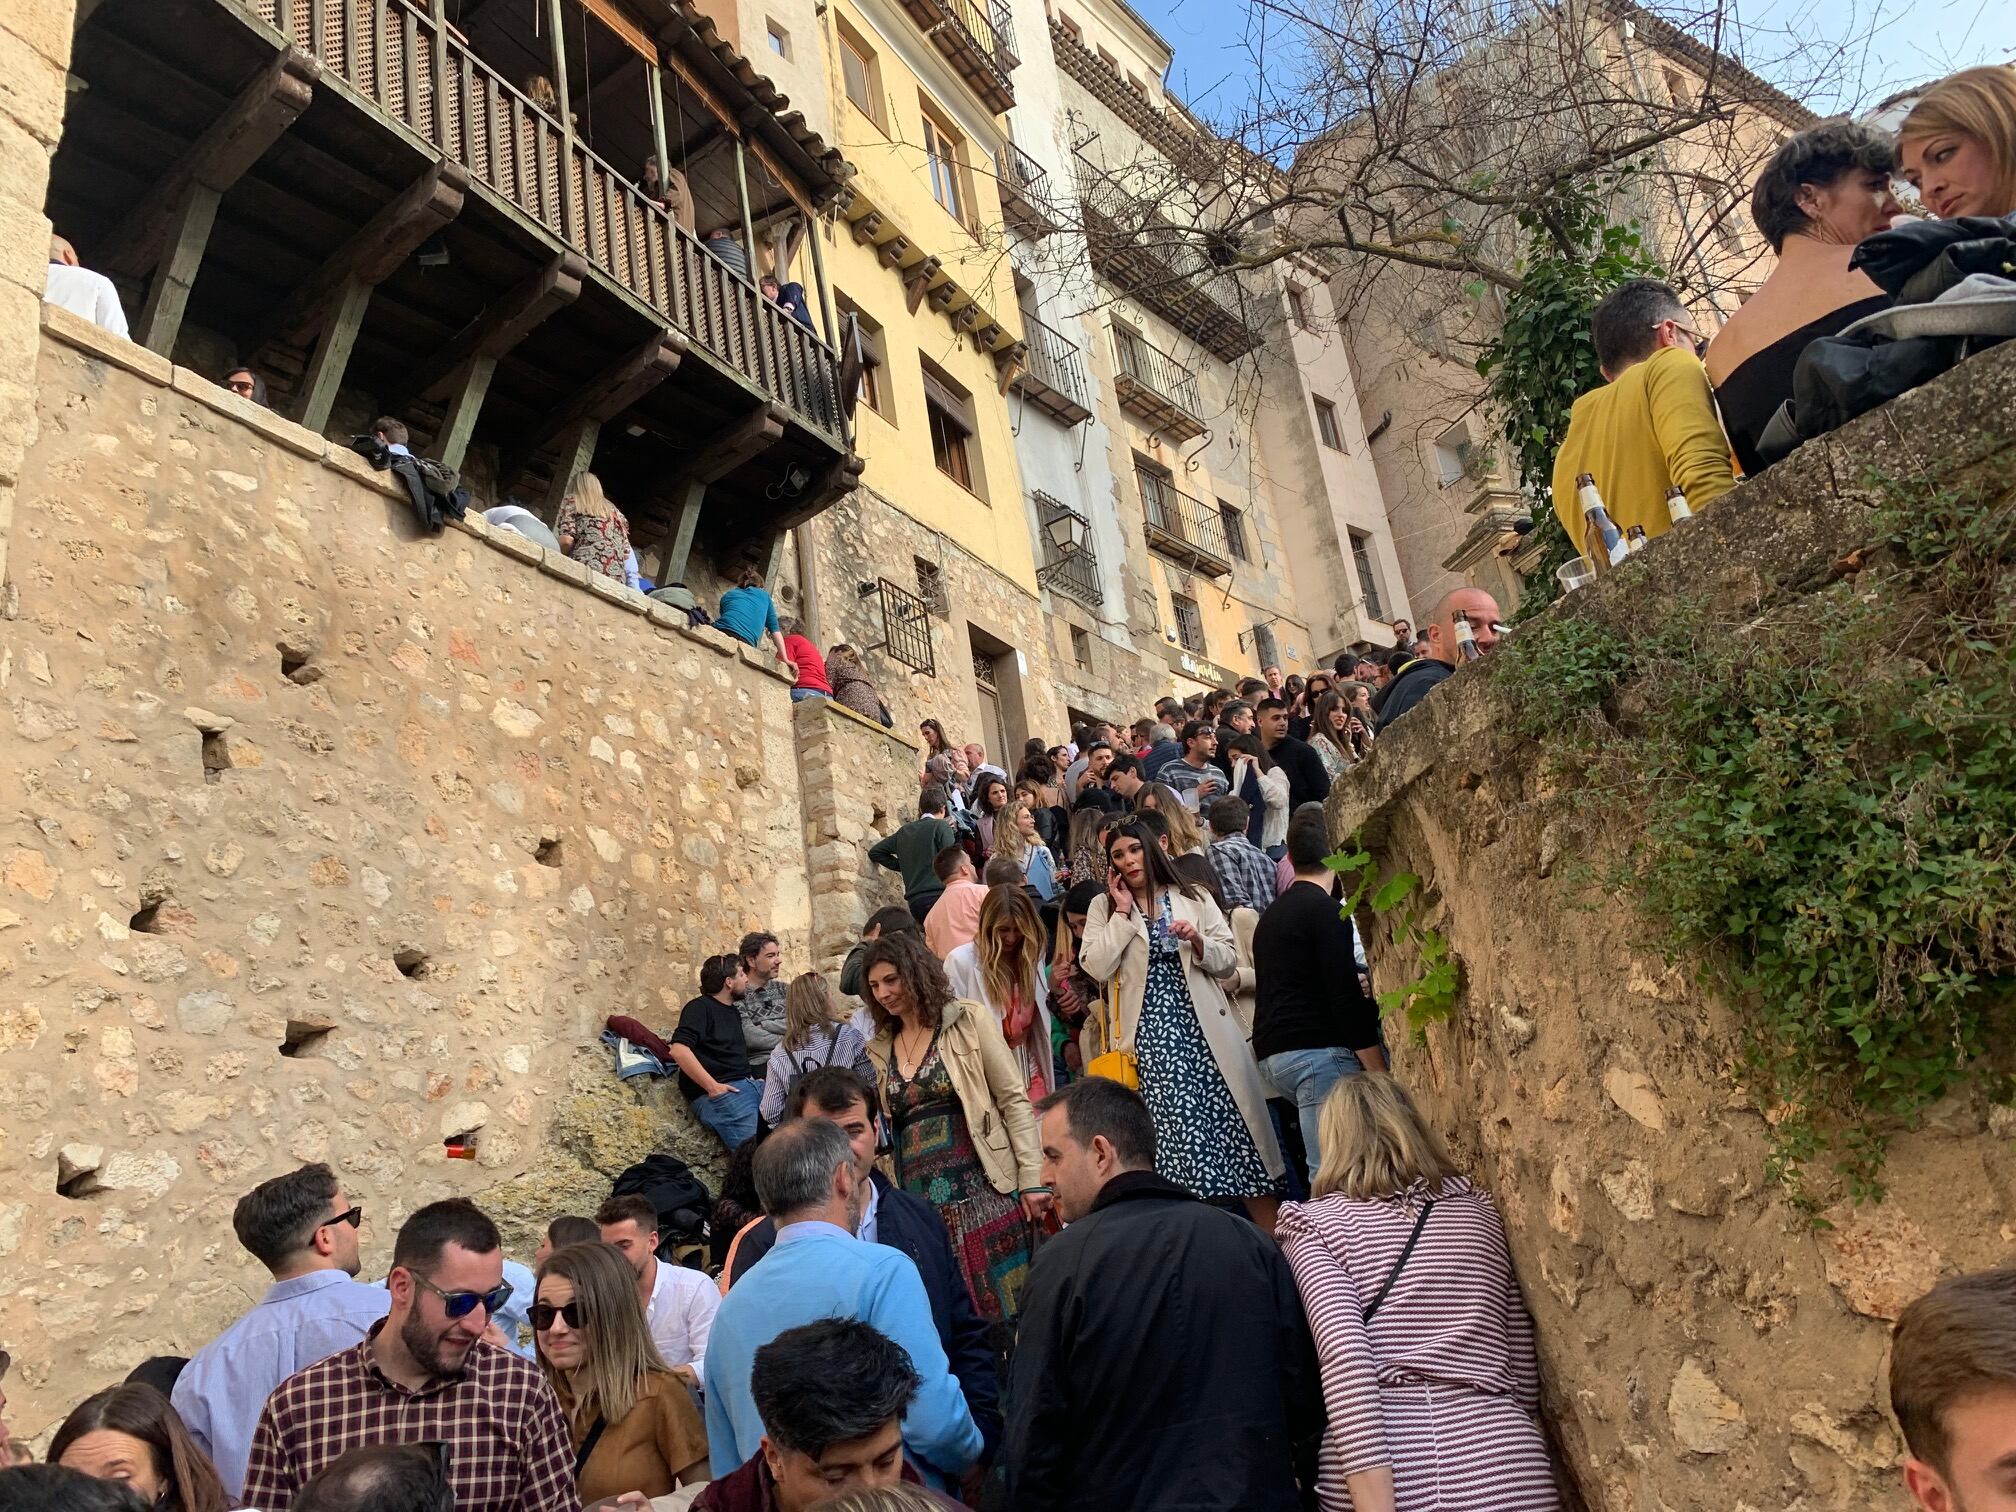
[173,1163,391,1498]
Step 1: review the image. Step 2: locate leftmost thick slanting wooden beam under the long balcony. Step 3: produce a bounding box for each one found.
[99,48,323,278]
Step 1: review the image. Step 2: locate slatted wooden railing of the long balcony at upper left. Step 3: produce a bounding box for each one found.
[245,0,843,444]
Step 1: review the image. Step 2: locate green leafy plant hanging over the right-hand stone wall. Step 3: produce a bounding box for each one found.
[1500,480,2016,1200]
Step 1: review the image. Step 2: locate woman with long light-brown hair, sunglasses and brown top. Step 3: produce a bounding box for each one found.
[532,1244,708,1506]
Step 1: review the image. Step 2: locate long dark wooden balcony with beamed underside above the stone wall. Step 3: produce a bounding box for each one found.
[50,0,853,564]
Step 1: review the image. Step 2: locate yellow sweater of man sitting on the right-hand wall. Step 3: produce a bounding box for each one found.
[1554,347,1736,564]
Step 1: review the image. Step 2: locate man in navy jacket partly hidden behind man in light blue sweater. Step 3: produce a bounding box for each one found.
[728,1066,1002,1464]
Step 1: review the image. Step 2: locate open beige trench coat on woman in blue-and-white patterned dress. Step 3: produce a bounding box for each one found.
[1079,893,1288,1179]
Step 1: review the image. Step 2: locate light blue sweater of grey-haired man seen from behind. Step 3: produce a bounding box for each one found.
[706,1222,980,1480]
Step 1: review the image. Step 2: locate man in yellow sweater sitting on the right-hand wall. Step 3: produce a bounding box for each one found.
[1554,278,1736,571]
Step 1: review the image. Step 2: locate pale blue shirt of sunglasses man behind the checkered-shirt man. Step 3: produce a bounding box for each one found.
[171,1270,391,1502]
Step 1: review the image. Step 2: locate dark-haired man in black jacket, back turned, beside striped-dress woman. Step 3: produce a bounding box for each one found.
[1002,1077,1325,1512]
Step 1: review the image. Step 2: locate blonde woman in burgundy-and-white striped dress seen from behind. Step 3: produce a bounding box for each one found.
[1276,1073,1560,1512]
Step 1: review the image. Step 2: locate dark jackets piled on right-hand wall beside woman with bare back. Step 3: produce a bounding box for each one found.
[1758,216,2016,464]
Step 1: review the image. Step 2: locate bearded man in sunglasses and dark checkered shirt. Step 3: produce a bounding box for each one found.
[242,1198,581,1512]
